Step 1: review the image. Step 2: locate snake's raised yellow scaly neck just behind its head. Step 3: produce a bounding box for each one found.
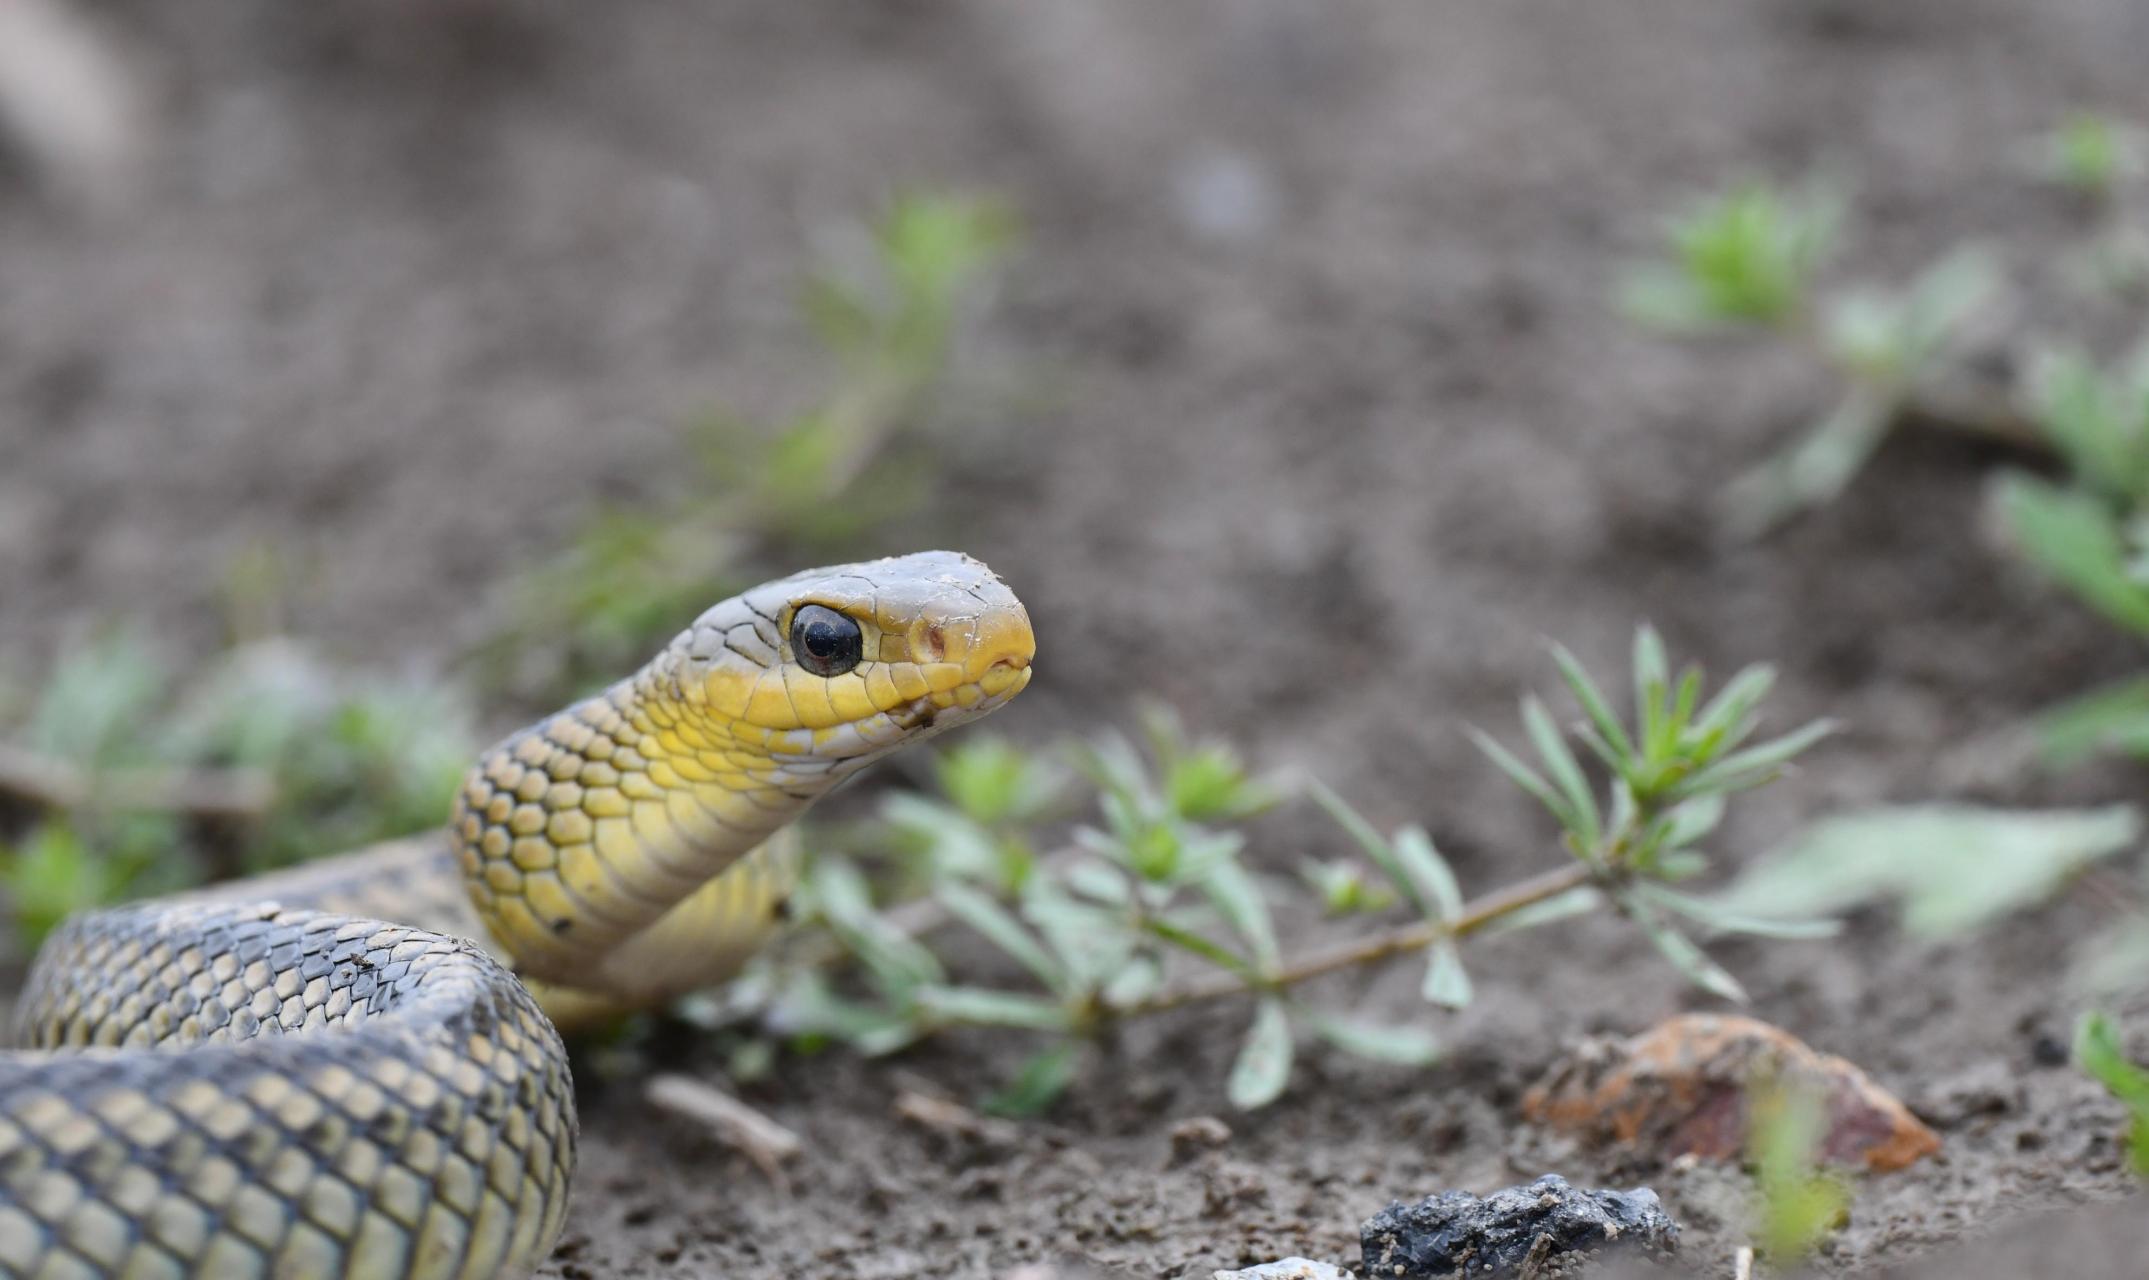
[449,649,825,990]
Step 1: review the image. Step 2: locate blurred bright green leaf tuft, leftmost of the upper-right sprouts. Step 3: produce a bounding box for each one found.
[1620,183,1842,331]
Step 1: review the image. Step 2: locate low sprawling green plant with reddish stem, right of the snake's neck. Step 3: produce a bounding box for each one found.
[756,629,1833,1112]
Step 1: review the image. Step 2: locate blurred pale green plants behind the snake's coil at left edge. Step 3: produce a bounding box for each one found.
[0,634,475,945]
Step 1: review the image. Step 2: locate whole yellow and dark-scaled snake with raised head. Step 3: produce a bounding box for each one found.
[0,552,1036,1280]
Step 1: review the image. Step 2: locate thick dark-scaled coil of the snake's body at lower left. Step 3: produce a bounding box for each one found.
[0,904,576,1280]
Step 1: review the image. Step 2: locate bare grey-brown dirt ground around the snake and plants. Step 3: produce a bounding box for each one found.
[0,0,2149,1280]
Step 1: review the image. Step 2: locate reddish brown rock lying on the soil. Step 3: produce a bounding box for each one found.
[1521,1014,1941,1173]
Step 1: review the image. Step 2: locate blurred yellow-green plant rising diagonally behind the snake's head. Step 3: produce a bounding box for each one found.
[479,193,1016,698]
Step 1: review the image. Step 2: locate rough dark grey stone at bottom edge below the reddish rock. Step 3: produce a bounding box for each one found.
[1358,1173,1678,1280]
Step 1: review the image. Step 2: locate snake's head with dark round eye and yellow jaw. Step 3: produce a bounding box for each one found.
[670,552,1036,773]
